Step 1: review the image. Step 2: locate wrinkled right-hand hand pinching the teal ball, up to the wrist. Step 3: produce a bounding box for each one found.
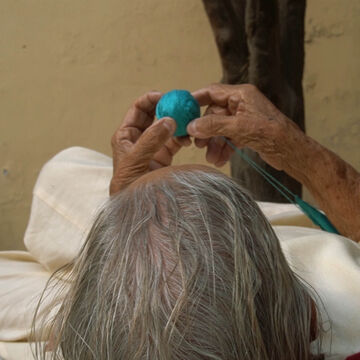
[187,84,296,170]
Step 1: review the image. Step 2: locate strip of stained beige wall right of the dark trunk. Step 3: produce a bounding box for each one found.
[304,0,360,170]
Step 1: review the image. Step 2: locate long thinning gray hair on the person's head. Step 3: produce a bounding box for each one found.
[32,170,322,360]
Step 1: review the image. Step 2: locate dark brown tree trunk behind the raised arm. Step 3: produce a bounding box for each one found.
[203,0,306,202]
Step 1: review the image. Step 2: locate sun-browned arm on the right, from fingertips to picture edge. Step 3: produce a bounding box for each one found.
[187,85,360,242]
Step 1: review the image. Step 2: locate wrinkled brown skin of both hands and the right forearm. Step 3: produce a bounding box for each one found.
[110,84,360,241]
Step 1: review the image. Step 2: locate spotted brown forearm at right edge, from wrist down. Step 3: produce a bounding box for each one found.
[279,120,360,242]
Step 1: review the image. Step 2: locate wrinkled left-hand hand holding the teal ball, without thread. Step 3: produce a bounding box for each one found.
[110,92,191,195]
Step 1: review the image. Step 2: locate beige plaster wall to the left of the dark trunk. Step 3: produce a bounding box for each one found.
[0,0,221,249]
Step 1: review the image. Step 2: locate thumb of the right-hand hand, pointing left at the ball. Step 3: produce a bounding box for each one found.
[186,114,236,139]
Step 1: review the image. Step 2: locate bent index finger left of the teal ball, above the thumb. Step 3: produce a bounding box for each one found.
[122,92,161,131]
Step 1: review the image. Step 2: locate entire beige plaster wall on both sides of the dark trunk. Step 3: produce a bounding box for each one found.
[0,0,360,249]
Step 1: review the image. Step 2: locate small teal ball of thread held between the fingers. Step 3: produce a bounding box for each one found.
[156,90,200,136]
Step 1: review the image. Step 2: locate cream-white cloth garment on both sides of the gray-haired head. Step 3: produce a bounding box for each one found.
[0,147,360,360]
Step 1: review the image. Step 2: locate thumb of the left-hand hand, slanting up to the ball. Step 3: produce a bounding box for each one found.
[132,117,176,163]
